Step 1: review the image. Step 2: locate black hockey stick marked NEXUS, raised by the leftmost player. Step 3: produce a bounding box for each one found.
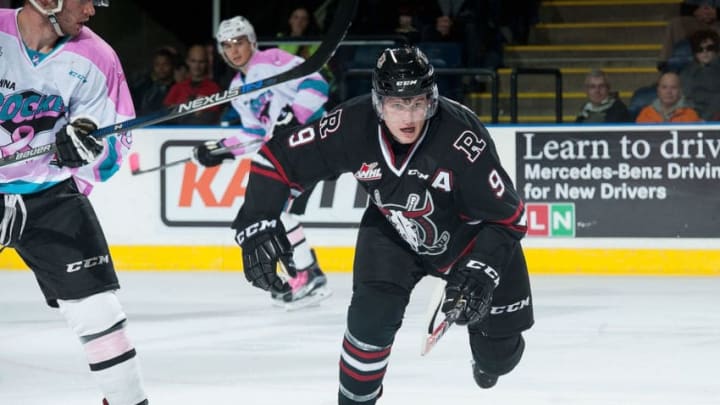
[0,0,358,167]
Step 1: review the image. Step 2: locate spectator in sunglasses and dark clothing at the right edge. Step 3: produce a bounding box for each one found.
[680,30,720,121]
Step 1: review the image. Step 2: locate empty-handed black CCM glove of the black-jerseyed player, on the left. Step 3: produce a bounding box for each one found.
[235,219,297,294]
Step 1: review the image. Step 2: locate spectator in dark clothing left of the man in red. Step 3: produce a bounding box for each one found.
[128,47,178,116]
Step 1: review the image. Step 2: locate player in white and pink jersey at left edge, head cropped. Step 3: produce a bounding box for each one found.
[0,0,148,405]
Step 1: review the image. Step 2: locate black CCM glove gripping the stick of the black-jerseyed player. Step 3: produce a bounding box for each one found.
[442,257,500,325]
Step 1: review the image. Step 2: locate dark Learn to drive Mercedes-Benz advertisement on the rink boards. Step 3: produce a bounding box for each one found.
[515,127,720,238]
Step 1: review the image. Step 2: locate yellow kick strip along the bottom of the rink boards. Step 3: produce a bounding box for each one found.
[0,246,720,276]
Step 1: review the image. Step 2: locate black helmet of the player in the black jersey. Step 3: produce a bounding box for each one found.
[372,46,438,119]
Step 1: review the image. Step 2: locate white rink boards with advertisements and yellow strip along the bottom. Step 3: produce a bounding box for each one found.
[0,125,720,275]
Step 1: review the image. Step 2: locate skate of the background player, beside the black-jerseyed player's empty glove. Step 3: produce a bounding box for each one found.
[272,262,332,311]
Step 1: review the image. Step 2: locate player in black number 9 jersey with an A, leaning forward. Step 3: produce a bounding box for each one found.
[232,47,533,405]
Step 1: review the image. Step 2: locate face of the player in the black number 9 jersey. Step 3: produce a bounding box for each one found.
[382,95,430,144]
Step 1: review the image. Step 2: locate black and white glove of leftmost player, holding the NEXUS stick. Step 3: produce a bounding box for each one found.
[55,118,103,167]
